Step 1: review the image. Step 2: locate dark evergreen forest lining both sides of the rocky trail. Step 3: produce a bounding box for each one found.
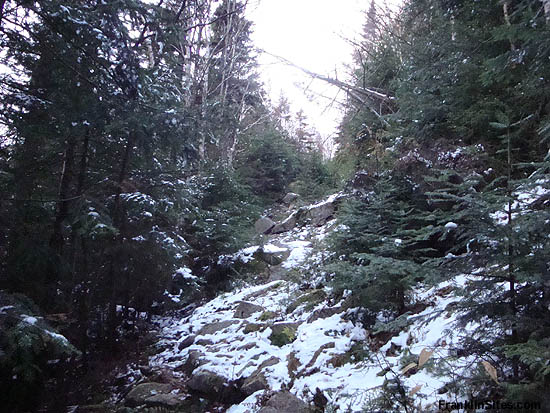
[0,0,550,412]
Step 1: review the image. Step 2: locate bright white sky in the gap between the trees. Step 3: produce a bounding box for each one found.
[248,0,370,146]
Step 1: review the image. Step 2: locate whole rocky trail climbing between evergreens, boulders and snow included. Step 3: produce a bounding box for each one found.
[113,195,473,413]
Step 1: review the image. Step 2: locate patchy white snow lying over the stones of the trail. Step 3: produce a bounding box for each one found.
[150,204,488,413]
